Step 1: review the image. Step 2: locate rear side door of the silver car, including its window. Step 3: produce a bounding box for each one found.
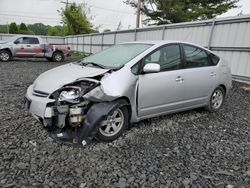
[182,44,218,107]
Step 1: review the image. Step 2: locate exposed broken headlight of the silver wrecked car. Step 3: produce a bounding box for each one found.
[59,87,81,101]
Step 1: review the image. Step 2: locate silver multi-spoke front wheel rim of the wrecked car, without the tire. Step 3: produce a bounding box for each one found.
[99,109,124,137]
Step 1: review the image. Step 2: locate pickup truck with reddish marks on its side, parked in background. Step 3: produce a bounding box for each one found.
[0,35,70,62]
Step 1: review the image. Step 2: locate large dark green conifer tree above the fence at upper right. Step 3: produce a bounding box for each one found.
[125,0,239,25]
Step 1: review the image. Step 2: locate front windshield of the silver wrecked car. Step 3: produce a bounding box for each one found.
[82,43,152,68]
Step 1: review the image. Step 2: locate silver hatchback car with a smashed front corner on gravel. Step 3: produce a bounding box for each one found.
[25,41,232,145]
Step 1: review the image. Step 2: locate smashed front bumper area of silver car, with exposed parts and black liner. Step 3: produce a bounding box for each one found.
[25,85,128,146]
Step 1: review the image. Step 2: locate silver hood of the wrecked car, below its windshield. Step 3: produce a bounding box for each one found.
[33,63,109,94]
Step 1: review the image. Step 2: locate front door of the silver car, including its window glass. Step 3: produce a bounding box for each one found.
[138,44,184,118]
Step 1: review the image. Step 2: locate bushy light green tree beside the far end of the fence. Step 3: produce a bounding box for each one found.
[61,4,95,35]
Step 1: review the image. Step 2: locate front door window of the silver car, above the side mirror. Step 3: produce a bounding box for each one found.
[145,44,181,71]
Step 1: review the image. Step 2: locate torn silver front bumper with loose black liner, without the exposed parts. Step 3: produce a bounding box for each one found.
[25,85,128,146]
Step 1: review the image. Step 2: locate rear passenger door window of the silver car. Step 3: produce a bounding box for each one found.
[183,44,211,68]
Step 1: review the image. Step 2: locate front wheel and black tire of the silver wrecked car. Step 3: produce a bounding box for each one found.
[95,107,129,142]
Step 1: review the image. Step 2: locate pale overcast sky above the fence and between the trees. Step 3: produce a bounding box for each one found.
[0,0,250,30]
